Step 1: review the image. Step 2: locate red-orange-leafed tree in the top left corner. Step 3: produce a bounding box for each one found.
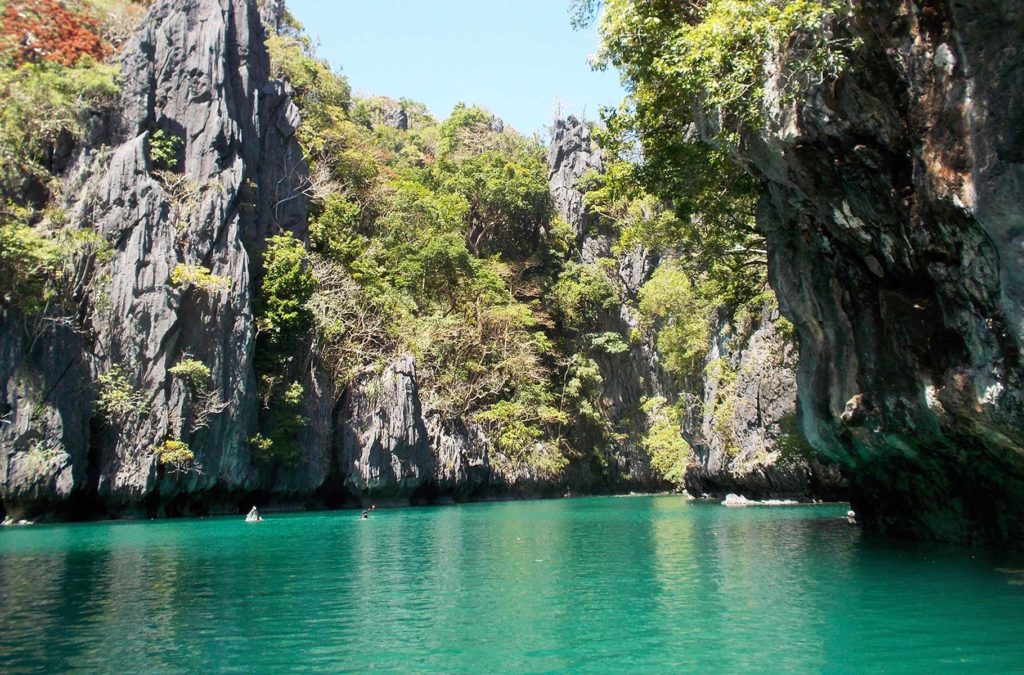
[0,0,110,66]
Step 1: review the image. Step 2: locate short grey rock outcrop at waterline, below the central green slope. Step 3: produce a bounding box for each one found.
[337,356,434,501]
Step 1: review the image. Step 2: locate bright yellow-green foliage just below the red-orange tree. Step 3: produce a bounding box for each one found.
[0,58,118,201]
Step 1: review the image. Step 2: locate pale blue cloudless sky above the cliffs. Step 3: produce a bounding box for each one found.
[288,0,623,134]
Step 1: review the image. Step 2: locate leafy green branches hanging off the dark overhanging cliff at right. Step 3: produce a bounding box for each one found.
[577,0,855,305]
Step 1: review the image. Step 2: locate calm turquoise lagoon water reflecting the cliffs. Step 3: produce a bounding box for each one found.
[0,497,1024,673]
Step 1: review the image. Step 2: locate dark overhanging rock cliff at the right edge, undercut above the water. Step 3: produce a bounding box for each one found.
[743,0,1024,544]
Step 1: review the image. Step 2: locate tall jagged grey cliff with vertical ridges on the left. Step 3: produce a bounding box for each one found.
[0,0,306,518]
